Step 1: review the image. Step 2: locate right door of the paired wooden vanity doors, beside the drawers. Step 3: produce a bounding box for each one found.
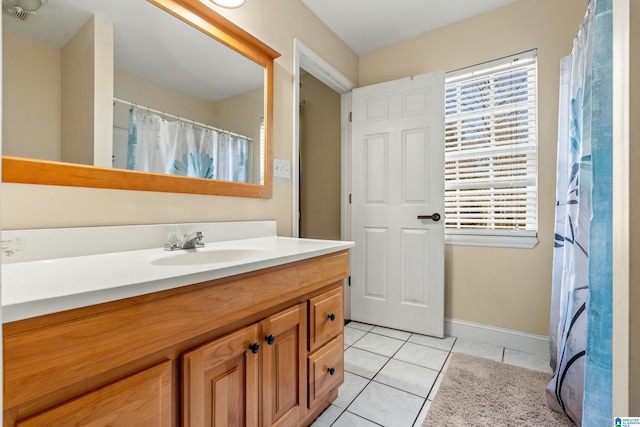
[260,303,307,426]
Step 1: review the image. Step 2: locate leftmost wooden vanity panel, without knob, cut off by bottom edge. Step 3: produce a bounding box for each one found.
[16,361,171,427]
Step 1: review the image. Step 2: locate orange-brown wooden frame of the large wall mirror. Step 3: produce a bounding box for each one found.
[2,0,279,198]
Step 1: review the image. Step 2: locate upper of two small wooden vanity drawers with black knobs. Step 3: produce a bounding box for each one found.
[309,286,344,351]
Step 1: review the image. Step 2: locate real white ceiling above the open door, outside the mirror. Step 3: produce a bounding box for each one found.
[302,0,518,55]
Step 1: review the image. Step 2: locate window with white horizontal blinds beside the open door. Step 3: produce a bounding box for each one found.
[445,50,537,248]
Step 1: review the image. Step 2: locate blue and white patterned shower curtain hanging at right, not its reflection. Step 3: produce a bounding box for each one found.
[547,0,612,426]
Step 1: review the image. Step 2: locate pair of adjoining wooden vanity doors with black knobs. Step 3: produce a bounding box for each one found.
[182,303,307,427]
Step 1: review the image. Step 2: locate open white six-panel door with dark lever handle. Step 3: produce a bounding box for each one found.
[351,72,444,337]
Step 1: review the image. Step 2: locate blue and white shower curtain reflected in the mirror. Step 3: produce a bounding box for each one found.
[127,107,251,182]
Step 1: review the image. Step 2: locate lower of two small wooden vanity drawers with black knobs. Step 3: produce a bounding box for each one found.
[309,334,344,408]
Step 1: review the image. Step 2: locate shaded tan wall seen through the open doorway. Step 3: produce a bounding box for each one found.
[300,74,342,240]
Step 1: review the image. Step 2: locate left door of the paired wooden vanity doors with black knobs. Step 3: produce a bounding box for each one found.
[182,325,258,427]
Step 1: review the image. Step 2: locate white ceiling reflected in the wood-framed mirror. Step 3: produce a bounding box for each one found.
[2,0,264,102]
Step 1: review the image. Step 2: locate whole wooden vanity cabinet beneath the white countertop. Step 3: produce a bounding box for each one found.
[3,251,349,427]
